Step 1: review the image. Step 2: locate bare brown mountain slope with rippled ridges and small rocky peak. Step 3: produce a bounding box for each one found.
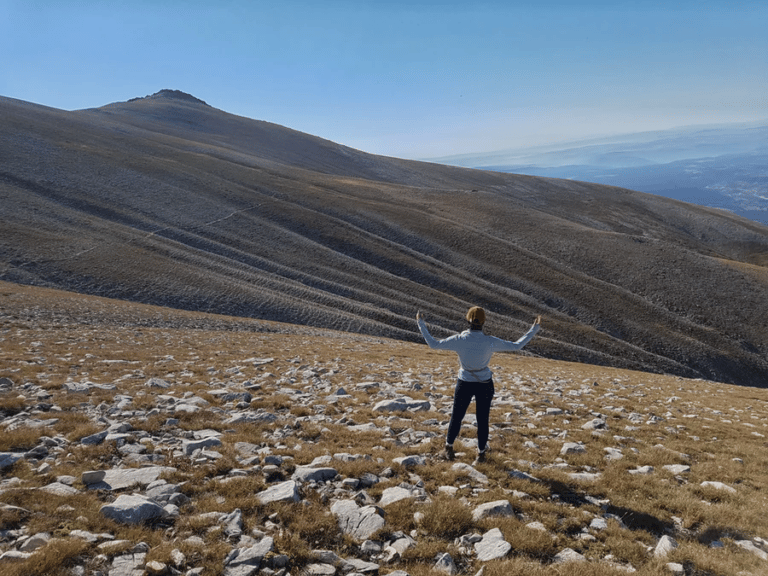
[0,91,768,385]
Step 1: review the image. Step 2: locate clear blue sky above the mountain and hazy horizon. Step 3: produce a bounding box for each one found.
[0,0,768,158]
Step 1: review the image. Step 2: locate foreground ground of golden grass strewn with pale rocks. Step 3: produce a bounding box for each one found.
[0,285,768,576]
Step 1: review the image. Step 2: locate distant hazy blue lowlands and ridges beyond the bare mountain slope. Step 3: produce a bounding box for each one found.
[432,123,768,224]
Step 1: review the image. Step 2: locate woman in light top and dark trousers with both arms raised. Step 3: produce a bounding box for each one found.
[416,306,541,464]
